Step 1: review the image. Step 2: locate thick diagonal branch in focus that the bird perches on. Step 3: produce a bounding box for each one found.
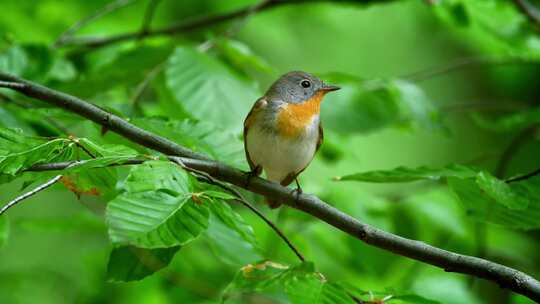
[0,73,540,301]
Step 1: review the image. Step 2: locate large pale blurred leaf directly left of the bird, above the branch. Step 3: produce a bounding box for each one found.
[166,47,259,131]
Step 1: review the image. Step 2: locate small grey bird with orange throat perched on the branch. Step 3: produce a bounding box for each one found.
[244,71,340,209]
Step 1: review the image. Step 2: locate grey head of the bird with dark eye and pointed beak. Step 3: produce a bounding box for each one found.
[265,71,339,103]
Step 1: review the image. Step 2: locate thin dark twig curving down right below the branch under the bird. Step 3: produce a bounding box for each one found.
[169,156,305,262]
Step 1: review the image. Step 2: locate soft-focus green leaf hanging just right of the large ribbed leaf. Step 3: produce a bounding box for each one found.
[205,198,262,266]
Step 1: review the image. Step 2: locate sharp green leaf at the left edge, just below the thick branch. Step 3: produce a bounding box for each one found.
[0,128,73,177]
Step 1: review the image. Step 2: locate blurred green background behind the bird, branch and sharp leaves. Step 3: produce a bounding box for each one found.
[0,0,540,304]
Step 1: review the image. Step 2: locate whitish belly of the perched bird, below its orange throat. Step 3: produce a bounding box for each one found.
[247,121,319,182]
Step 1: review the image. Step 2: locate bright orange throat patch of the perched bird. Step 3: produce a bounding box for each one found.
[277,91,325,138]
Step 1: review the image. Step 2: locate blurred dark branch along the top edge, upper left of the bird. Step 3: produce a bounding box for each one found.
[56,0,392,48]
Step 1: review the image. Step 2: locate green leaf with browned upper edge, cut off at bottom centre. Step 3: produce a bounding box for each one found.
[224,261,355,304]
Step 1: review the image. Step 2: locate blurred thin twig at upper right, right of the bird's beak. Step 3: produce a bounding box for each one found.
[401,56,534,82]
